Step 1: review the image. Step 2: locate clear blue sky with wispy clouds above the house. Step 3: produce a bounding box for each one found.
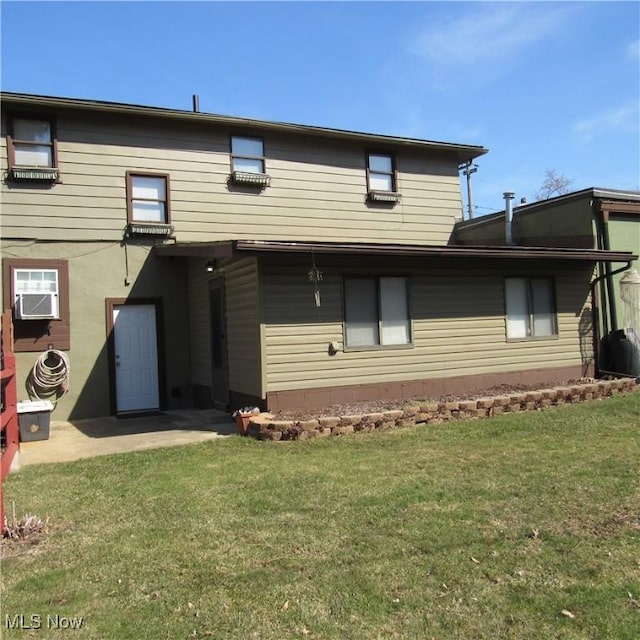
[1,0,640,216]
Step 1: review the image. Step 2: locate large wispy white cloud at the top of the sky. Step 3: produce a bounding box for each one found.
[409,2,567,68]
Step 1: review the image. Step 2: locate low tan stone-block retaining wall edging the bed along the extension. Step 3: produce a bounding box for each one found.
[249,378,636,440]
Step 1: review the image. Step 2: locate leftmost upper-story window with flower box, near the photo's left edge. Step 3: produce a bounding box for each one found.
[7,116,58,180]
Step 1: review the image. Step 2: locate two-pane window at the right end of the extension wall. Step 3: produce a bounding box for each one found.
[505,278,558,340]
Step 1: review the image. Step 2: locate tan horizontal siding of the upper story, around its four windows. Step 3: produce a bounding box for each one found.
[0,111,462,244]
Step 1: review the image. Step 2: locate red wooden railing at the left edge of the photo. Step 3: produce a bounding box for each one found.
[0,311,20,531]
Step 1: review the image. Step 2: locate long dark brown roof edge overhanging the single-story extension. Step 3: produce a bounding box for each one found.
[154,240,638,262]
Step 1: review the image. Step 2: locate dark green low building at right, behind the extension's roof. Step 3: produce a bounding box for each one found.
[454,188,640,372]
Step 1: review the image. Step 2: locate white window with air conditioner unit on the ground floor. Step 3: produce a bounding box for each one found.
[13,269,60,320]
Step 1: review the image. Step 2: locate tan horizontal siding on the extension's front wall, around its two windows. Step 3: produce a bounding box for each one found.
[264,261,592,391]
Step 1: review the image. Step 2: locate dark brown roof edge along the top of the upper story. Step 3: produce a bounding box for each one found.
[0,92,489,162]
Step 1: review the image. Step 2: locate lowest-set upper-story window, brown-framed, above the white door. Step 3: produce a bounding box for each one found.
[127,172,171,235]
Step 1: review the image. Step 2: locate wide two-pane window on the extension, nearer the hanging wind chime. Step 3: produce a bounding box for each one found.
[344,277,411,347]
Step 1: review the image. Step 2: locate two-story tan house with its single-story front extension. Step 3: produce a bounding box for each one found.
[0,93,635,419]
